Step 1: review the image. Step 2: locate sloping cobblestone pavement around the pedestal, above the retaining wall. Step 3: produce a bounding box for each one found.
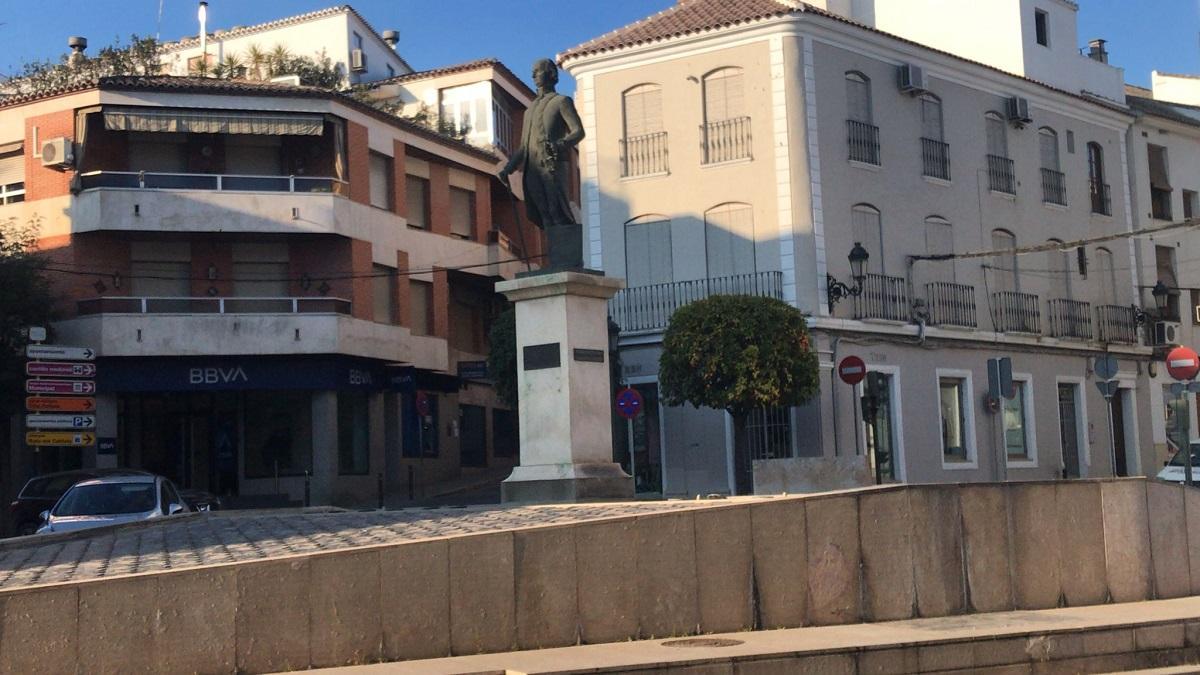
[0,501,727,590]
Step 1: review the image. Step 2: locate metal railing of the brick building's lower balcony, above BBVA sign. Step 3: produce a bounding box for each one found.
[77,297,350,315]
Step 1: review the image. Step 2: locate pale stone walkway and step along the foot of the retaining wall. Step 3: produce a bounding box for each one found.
[302,597,1200,675]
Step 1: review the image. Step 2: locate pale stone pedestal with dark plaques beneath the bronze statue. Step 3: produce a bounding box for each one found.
[496,271,634,502]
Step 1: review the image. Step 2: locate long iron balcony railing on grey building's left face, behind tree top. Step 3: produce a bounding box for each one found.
[608,271,784,333]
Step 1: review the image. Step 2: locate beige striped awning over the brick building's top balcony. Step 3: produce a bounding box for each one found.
[104,108,325,136]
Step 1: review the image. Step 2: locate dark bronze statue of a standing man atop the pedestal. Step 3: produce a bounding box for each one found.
[500,59,583,270]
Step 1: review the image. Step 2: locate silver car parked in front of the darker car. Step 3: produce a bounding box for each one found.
[37,474,190,534]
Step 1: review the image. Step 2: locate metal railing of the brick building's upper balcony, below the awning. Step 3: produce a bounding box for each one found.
[79,171,349,197]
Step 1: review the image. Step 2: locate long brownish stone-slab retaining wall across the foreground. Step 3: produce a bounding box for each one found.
[0,479,1200,673]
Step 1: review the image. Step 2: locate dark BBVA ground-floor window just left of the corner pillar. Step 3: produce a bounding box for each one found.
[244,392,312,478]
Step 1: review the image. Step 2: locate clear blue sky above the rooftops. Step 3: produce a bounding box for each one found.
[0,0,1200,89]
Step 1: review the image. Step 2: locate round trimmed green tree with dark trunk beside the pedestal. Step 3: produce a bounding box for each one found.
[659,295,820,492]
